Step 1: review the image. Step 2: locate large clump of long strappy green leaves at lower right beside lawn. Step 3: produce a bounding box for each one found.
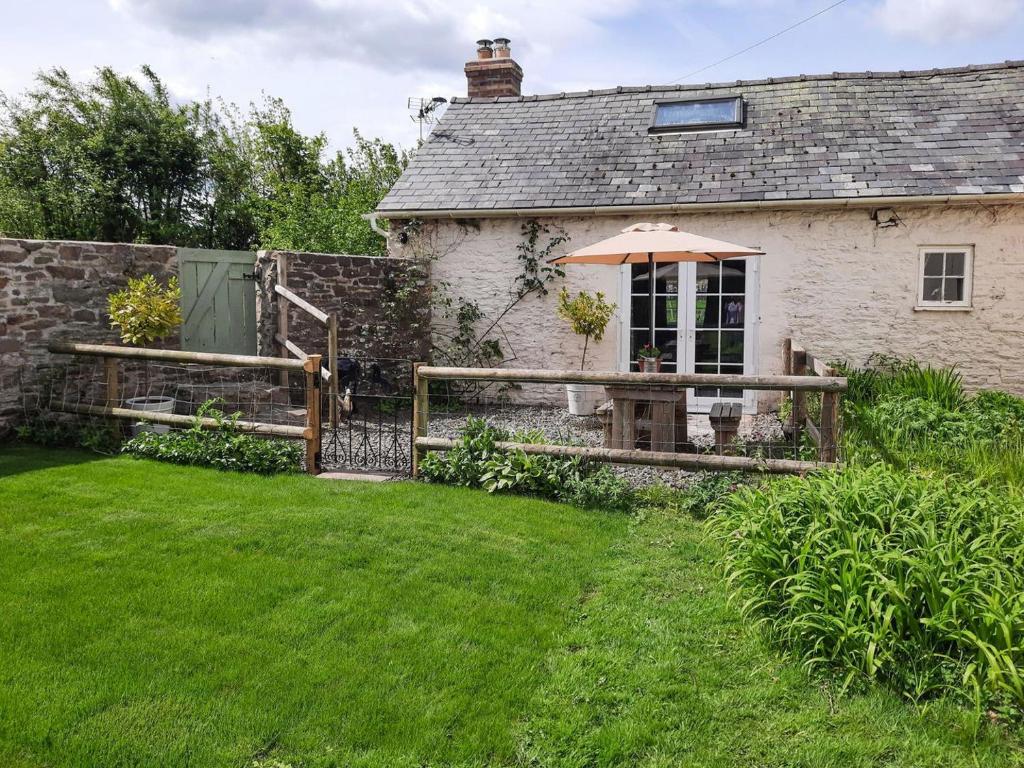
[710,465,1024,713]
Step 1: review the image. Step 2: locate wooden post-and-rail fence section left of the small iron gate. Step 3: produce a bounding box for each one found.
[47,341,322,474]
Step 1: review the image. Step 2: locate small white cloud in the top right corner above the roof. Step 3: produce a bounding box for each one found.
[874,0,1024,43]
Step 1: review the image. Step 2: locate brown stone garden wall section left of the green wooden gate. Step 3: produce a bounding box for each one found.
[0,239,176,436]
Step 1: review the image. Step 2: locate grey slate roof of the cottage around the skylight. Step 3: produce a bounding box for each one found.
[378,60,1024,215]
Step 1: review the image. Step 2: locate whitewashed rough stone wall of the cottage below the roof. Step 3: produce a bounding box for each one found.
[394,205,1024,405]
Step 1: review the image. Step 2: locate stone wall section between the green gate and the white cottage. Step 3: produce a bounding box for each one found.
[257,251,430,384]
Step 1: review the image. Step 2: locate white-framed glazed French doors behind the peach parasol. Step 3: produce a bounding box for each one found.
[620,258,758,413]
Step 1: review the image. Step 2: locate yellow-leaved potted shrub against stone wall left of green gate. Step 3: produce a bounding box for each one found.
[106,274,181,434]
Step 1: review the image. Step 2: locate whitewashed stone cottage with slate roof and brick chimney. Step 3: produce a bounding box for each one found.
[377,40,1024,410]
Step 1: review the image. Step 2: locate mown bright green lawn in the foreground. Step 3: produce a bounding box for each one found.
[0,449,1024,768]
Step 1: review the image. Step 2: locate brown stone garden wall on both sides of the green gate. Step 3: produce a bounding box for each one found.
[0,239,430,438]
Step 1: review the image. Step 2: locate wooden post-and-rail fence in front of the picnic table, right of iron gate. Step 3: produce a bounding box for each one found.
[412,364,847,477]
